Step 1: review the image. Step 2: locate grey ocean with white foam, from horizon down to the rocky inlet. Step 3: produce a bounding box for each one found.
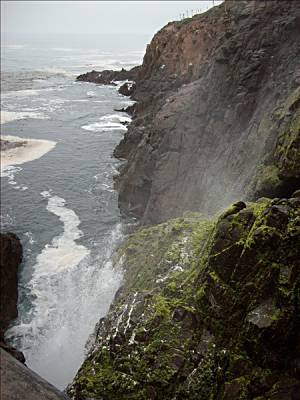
[1,35,149,389]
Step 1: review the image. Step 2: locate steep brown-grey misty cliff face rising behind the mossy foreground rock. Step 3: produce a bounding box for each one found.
[115,1,300,223]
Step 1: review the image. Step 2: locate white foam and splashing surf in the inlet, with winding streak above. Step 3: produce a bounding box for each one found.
[8,191,122,388]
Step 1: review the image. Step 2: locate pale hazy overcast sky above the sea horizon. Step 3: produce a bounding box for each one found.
[1,0,219,34]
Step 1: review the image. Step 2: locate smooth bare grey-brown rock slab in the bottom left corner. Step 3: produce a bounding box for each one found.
[0,348,68,400]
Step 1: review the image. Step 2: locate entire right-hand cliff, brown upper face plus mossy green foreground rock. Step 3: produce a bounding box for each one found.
[68,1,300,400]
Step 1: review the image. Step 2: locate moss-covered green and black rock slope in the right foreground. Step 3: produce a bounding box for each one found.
[69,197,300,400]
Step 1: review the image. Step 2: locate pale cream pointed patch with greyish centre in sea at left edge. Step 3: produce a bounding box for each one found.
[1,135,56,172]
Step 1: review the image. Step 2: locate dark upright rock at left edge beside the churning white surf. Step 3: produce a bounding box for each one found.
[0,233,25,362]
